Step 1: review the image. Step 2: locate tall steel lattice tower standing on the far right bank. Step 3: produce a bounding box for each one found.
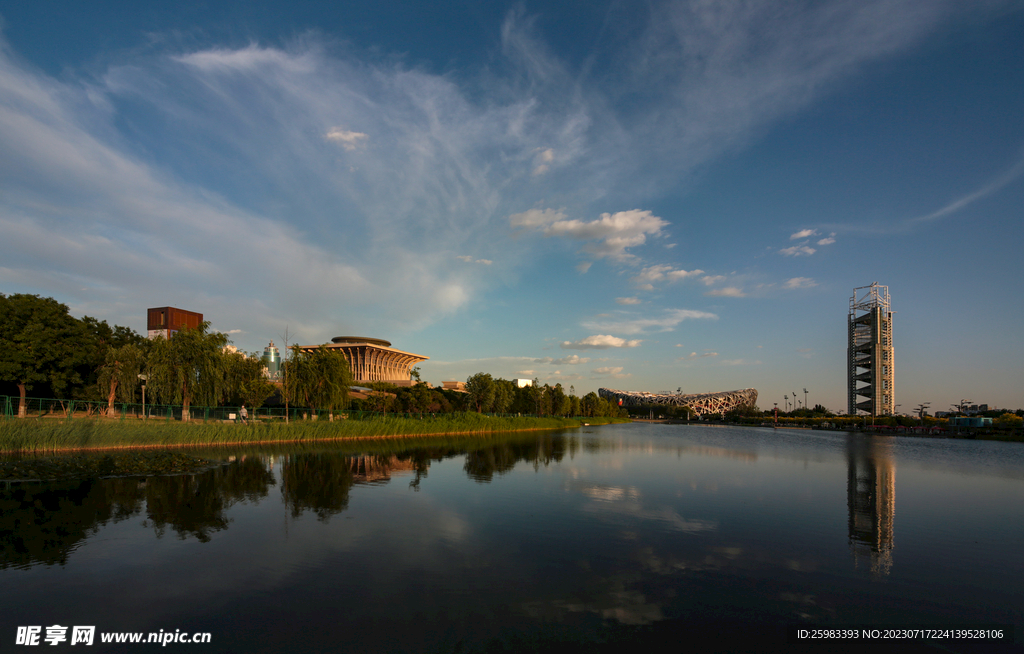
[846,281,896,417]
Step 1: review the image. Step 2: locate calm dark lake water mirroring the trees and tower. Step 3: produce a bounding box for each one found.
[0,424,1024,652]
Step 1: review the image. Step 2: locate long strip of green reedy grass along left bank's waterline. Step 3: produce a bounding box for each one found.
[0,412,626,453]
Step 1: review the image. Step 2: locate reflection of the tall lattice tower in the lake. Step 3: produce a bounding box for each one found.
[846,436,896,574]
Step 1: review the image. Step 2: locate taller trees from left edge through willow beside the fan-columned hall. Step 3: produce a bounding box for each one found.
[0,294,351,418]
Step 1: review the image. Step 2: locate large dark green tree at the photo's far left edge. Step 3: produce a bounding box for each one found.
[0,294,89,418]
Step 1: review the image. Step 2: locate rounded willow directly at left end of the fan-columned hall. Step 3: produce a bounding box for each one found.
[285,345,352,411]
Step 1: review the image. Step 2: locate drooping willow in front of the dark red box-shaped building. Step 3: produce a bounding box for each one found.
[148,320,227,420]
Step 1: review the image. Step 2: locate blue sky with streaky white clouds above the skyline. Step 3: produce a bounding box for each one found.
[0,0,1024,412]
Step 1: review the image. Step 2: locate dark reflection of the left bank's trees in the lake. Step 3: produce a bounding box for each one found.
[0,433,582,567]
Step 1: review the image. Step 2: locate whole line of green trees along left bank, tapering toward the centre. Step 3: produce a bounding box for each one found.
[0,294,626,419]
